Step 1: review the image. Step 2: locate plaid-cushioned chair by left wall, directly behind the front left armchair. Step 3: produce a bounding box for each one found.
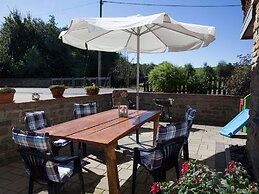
[24,111,74,156]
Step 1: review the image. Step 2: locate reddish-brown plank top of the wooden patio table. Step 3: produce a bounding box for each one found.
[38,109,160,146]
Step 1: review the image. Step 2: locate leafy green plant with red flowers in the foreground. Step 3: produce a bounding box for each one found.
[151,161,259,194]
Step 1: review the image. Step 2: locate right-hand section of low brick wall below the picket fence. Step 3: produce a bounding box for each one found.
[140,93,240,126]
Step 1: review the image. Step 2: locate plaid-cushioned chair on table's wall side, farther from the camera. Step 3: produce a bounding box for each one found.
[73,102,97,156]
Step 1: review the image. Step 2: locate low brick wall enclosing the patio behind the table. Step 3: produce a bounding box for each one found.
[0,93,240,163]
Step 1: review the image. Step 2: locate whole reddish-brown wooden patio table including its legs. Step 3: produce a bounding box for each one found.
[37,109,160,194]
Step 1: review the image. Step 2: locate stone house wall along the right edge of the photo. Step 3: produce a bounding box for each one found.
[246,3,259,182]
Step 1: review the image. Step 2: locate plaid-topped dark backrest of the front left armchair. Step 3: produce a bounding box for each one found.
[12,128,62,182]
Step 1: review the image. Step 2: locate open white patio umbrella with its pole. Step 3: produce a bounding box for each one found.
[59,13,216,109]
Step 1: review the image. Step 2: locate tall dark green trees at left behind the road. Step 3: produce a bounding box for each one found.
[0,10,119,77]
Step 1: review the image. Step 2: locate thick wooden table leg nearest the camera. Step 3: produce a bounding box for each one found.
[104,144,120,194]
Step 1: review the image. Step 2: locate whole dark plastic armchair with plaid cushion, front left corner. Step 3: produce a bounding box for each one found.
[12,129,85,194]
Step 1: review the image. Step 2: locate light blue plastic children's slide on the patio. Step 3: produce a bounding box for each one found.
[220,109,249,137]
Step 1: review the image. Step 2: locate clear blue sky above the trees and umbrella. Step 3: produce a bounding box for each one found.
[0,0,253,67]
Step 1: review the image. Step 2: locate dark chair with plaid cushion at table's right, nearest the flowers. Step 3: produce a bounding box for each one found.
[132,137,184,194]
